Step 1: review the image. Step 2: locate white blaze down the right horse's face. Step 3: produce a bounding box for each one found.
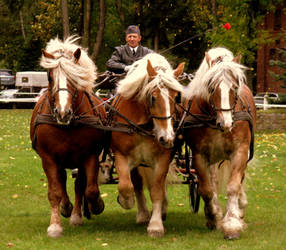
[220,82,233,128]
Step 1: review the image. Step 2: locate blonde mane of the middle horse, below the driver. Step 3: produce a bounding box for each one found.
[117,53,183,101]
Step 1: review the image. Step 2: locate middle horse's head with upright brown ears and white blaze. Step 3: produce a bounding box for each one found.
[146,60,184,148]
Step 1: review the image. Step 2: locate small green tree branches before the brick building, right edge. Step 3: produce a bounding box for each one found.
[270,47,286,88]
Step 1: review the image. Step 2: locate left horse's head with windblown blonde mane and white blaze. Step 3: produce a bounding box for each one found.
[41,37,96,125]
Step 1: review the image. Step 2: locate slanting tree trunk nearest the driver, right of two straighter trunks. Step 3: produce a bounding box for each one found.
[92,0,106,61]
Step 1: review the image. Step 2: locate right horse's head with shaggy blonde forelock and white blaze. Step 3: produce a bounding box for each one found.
[206,56,245,131]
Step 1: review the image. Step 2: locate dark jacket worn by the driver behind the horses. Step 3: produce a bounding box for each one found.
[106,44,153,74]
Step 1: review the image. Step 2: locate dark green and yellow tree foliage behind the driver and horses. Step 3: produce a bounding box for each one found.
[0,0,282,79]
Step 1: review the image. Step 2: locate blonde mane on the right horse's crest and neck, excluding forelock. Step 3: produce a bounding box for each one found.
[184,47,237,98]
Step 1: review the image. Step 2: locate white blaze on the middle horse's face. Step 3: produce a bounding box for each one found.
[158,88,174,141]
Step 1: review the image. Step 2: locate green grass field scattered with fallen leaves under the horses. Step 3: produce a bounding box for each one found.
[0,110,286,250]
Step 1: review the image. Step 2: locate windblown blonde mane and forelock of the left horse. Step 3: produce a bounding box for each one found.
[40,36,97,93]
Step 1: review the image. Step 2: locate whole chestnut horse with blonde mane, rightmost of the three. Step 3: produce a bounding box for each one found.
[181,47,256,239]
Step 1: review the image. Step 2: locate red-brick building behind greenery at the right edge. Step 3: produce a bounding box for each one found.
[256,3,286,93]
